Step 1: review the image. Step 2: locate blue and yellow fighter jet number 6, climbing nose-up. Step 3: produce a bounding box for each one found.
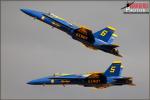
[21,9,122,57]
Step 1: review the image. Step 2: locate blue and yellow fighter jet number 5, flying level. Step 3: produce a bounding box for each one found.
[27,61,134,89]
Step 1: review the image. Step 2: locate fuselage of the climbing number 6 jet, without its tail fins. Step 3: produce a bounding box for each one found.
[21,9,121,57]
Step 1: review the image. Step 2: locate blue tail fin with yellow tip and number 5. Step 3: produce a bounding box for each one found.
[104,61,123,77]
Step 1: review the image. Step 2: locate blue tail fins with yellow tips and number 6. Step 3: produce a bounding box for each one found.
[94,26,117,44]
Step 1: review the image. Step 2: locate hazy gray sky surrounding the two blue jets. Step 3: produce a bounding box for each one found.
[1,1,149,99]
